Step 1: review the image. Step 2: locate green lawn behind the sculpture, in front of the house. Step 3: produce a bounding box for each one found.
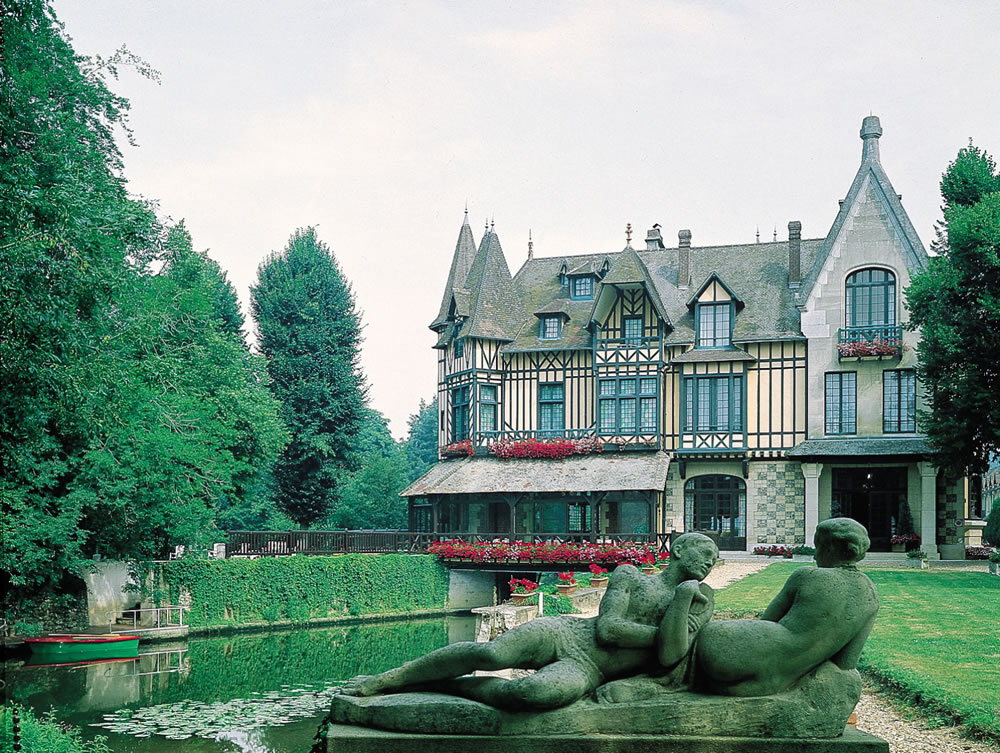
[716,562,1000,741]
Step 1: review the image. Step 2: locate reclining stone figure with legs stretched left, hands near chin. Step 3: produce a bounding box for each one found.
[342,533,719,710]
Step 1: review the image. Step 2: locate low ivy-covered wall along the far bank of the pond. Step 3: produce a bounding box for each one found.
[154,554,448,627]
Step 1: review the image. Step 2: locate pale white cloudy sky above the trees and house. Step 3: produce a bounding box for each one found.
[55,0,1000,437]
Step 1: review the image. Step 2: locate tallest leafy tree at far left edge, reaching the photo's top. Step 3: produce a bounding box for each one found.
[0,0,159,593]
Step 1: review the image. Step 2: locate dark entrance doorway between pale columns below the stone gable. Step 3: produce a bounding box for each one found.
[830,468,906,552]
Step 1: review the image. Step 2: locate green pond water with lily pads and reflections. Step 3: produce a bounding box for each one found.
[4,615,475,753]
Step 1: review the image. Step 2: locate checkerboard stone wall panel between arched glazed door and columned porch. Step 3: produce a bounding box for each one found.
[749,462,806,545]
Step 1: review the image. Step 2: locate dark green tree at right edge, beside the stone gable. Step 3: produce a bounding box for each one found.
[906,141,1000,474]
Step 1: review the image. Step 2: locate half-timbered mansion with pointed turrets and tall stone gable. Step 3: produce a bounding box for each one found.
[403,117,964,556]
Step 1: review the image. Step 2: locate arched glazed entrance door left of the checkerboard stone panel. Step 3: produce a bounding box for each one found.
[684,476,747,551]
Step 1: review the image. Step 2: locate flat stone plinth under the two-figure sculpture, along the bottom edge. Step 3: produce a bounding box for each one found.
[314,724,889,753]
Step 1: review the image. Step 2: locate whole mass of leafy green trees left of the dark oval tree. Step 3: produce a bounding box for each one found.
[0,0,286,601]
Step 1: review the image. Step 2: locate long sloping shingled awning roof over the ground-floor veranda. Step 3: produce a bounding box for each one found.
[399,452,670,497]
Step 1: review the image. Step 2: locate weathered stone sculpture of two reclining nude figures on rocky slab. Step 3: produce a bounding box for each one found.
[331,518,884,750]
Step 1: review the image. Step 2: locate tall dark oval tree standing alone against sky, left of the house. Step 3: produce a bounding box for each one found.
[250,227,366,527]
